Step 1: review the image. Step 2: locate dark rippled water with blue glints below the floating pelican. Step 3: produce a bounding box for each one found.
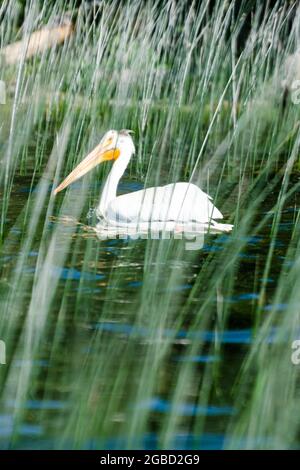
[0,174,297,449]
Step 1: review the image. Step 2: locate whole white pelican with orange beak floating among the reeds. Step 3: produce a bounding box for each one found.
[54,130,232,232]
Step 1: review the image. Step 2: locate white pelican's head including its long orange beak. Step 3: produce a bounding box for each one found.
[54,129,135,194]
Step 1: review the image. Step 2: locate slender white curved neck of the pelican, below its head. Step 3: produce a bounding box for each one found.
[97,149,132,217]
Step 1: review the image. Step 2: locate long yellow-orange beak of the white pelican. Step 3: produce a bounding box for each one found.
[54,138,120,194]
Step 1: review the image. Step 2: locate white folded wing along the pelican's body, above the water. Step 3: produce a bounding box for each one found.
[107,183,223,223]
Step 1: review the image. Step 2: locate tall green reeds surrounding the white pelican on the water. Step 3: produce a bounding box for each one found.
[0,0,299,448]
